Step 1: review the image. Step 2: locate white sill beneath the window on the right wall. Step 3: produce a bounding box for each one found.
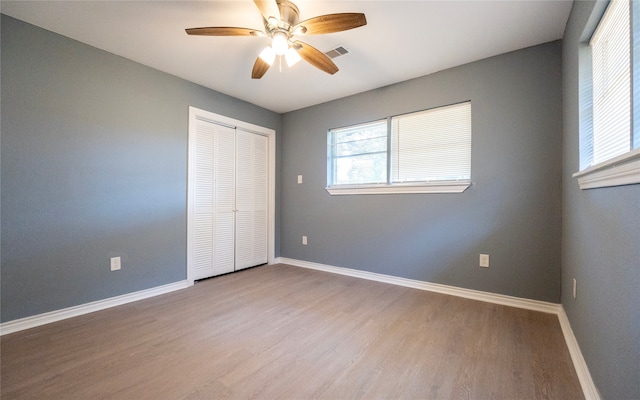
[573,149,640,189]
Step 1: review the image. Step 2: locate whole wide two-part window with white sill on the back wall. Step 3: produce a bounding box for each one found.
[327,102,471,194]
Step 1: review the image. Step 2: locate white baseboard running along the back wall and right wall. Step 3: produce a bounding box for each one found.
[275,257,600,400]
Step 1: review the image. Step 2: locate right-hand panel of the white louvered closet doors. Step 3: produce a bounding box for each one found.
[236,129,268,270]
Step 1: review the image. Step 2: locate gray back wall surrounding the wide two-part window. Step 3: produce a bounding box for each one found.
[280,41,562,303]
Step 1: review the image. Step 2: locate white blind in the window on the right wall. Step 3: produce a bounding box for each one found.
[583,0,632,167]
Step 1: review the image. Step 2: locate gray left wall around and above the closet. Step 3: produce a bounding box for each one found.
[1,15,281,321]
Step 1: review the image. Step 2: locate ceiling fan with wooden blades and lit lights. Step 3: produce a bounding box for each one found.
[186,0,367,79]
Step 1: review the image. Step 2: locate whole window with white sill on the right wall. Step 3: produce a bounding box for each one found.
[574,0,640,189]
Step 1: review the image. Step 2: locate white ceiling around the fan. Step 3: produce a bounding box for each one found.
[0,0,572,113]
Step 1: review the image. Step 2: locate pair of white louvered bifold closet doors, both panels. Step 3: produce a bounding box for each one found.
[191,119,268,280]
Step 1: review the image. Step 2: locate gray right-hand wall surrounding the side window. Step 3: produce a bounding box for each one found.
[562,1,640,399]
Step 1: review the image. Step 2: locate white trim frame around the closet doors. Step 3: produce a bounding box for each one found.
[187,107,276,284]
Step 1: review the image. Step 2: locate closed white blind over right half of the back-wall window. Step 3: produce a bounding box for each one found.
[391,102,471,182]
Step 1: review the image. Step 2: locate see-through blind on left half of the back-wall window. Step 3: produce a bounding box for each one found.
[330,120,387,185]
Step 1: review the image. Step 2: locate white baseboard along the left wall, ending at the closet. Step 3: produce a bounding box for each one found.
[0,280,193,336]
